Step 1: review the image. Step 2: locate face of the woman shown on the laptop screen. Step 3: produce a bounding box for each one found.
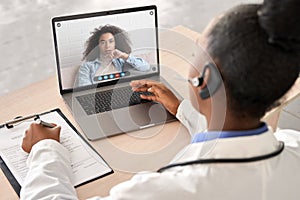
[98,33,116,55]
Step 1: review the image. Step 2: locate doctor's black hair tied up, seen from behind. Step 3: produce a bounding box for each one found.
[207,0,300,118]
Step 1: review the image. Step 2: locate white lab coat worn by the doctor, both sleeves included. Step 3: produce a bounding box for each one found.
[21,100,300,200]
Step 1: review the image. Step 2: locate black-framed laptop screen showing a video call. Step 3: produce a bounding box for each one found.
[52,6,159,92]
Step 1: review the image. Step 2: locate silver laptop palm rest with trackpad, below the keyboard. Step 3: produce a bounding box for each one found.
[77,102,175,140]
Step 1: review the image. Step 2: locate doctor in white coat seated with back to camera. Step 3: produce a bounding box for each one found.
[21,0,300,200]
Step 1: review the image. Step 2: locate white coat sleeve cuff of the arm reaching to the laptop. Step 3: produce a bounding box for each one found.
[176,99,207,136]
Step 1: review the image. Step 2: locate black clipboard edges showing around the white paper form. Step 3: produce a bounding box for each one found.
[0,108,114,196]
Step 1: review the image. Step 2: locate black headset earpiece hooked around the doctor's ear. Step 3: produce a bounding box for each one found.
[199,63,222,99]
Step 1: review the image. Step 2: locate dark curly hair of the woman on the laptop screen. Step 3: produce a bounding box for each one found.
[82,25,131,61]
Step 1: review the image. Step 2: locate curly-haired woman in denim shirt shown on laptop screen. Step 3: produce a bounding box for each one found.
[77,25,150,86]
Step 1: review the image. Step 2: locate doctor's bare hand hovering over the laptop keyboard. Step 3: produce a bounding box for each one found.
[130,80,180,115]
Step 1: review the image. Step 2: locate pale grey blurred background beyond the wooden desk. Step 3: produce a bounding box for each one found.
[0,0,262,98]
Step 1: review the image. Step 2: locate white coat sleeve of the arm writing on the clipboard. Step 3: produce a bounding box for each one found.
[20,139,77,200]
